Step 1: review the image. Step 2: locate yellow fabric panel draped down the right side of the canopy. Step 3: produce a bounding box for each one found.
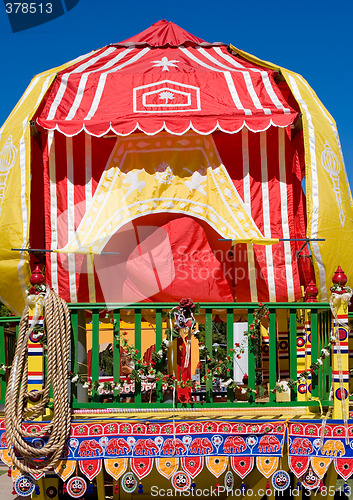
[231,46,353,301]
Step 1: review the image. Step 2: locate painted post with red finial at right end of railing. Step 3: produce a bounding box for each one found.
[330,266,352,421]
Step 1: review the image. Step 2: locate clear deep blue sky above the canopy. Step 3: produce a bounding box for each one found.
[0,0,353,182]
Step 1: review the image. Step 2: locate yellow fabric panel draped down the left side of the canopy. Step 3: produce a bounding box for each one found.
[0,56,96,315]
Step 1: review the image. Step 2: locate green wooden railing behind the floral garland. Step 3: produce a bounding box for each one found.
[0,303,332,409]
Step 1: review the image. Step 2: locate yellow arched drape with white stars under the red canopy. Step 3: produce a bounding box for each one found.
[60,132,268,253]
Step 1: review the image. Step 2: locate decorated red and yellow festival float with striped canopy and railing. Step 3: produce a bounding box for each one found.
[0,21,353,500]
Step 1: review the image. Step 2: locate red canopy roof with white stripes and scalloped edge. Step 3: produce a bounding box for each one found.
[37,21,297,136]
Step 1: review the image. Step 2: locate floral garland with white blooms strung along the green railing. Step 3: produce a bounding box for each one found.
[65,299,336,397]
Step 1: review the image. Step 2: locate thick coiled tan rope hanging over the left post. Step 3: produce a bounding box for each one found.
[5,289,71,473]
